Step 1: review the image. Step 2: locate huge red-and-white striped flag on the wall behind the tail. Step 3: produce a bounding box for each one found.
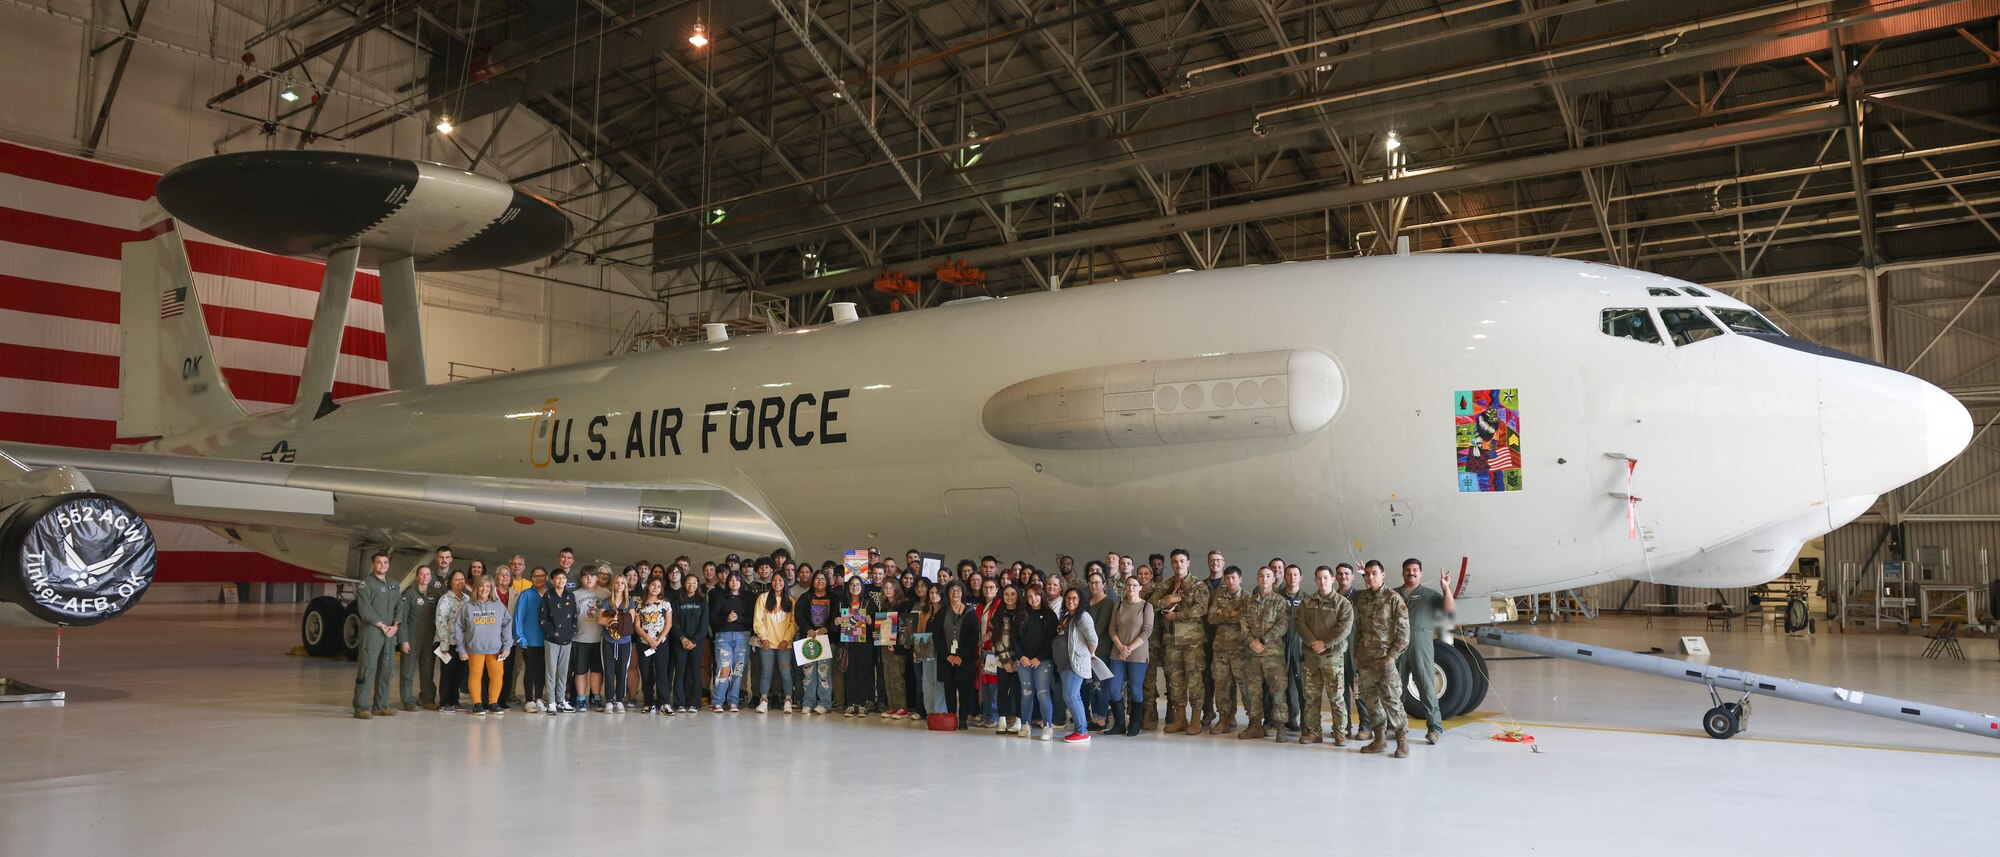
[0,142,388,583]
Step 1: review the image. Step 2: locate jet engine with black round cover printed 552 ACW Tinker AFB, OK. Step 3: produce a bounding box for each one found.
[0,467,158,625]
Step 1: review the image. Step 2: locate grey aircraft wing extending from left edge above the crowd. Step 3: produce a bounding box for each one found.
[0,443,786,573]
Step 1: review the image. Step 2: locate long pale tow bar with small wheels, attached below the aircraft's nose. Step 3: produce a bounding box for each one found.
[1472,629,2000,739]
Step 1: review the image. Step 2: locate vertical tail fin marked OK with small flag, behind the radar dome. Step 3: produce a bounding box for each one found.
[118,204,246,439]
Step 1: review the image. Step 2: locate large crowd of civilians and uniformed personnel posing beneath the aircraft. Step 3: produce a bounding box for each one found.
[354,549,1456,759]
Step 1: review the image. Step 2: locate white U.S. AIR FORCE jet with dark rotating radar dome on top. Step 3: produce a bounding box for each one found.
[8,152,1972,716]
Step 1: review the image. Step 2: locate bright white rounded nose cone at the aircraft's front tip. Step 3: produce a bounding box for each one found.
[1820,356,1972,499]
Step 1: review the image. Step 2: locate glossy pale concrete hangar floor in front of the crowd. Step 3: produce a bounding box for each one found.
[0,605,2000,857]
